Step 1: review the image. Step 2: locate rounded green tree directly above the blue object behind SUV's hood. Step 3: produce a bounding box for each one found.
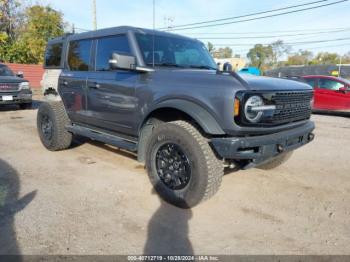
[247,44,273,71]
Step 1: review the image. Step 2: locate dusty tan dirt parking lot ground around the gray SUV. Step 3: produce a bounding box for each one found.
[0,102,350,255]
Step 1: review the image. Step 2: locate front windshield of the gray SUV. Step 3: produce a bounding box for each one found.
[136,34,216,69]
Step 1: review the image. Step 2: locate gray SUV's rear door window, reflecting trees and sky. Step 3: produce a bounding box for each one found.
[68,40,92,71]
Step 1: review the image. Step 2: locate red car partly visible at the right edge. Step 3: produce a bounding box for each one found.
[302,75,350,113]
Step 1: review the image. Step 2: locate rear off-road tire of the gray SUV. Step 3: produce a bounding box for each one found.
[37,102,72,151]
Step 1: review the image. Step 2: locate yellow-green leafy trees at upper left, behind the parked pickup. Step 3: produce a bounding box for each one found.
[0,0,64,64]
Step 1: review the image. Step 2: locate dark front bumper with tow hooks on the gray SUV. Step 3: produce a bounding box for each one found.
[211,121,315,169]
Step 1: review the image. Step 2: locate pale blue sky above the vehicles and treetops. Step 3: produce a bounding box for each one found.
[40,0,350,56]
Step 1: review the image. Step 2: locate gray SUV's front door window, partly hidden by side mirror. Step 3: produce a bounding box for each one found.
[96,35,131,71]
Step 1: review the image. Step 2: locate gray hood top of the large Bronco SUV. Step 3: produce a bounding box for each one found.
[238,74,312,90]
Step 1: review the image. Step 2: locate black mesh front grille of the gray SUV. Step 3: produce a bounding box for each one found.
[268,91,313,125]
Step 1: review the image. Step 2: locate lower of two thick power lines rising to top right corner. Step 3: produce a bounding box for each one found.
[167,0,349,31]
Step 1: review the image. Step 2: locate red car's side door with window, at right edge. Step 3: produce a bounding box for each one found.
[317,78,350,110]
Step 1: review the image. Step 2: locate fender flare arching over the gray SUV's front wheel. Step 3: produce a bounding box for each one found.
[146,99,225,135]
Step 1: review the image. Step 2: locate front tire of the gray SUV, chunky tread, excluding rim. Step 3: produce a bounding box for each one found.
[146,121,224,208]
